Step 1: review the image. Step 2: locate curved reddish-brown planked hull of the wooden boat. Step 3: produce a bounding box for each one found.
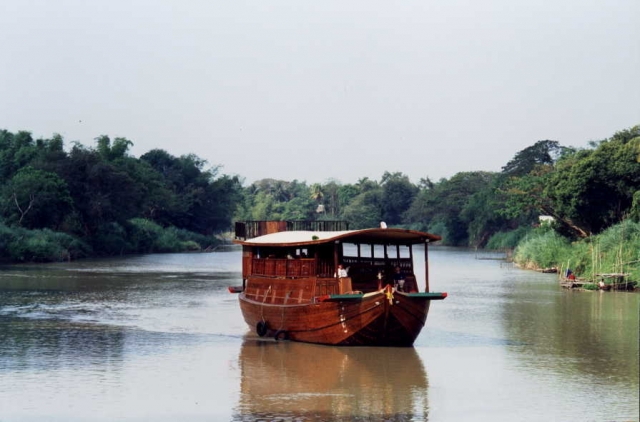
[239,286,446,346]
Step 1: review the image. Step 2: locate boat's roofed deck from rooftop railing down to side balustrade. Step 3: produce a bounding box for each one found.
[234,221,440,291]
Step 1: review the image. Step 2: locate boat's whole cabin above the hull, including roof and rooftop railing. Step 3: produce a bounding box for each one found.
[235,221,440,303]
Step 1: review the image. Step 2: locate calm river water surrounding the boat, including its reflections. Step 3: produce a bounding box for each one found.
[0,247,640,422]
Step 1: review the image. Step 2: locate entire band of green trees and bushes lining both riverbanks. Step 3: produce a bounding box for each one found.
[0,126,640,286]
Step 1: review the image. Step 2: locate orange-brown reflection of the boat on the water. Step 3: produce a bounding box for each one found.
[234,339,429,421]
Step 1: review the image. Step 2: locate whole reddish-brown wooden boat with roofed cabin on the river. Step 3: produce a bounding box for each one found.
[229,221,447,346]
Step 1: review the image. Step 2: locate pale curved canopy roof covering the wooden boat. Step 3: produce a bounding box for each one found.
[234,228,441,247]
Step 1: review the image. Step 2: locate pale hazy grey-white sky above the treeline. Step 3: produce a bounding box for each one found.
[0,0,640,183]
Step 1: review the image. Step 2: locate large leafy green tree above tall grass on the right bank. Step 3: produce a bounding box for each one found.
[502,126,640,238]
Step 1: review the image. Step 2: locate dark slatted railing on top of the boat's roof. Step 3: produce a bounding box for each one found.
[236,220,349,240]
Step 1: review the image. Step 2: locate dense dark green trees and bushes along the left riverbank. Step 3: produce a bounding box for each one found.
[0,130,242,261]
